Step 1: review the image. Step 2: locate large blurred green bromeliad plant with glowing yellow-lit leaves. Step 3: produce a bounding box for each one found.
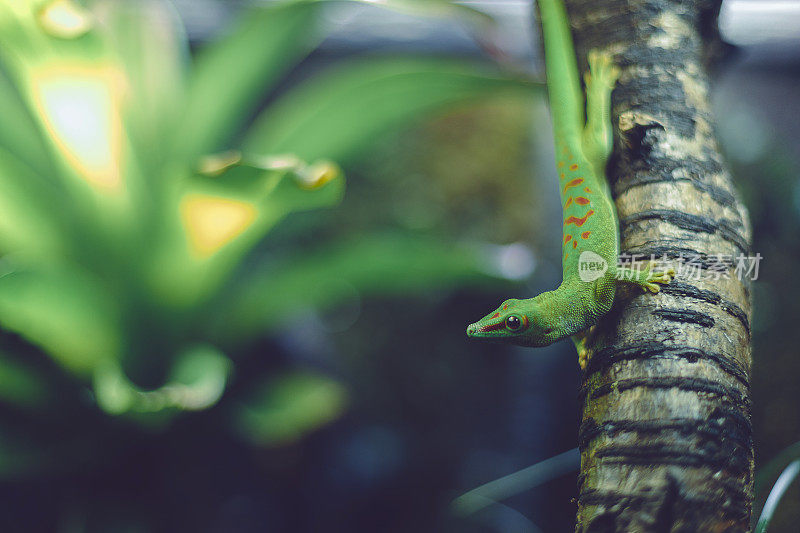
[0,0,537,420]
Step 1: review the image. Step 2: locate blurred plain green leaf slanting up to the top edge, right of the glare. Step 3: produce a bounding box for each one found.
[176,2,321,161]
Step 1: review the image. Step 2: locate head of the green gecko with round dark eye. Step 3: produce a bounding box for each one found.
[467,295,563,346]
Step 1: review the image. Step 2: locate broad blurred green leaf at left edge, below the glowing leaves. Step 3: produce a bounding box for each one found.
[0,267,121,375]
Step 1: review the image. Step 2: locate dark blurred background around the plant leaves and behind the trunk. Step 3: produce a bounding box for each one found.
[0,1,800,532]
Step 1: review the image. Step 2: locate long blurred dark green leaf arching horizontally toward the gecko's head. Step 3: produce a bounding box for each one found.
[216,234,506,340]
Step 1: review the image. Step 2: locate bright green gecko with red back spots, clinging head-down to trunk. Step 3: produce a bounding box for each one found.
[467,0,675,368]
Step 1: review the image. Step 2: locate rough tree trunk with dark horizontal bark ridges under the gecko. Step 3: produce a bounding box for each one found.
[566,0,753,532]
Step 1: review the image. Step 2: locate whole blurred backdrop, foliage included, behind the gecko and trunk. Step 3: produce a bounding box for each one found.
[0,0,800,532]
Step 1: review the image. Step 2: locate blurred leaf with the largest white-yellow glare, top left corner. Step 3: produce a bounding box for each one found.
[0,0,155,241]
